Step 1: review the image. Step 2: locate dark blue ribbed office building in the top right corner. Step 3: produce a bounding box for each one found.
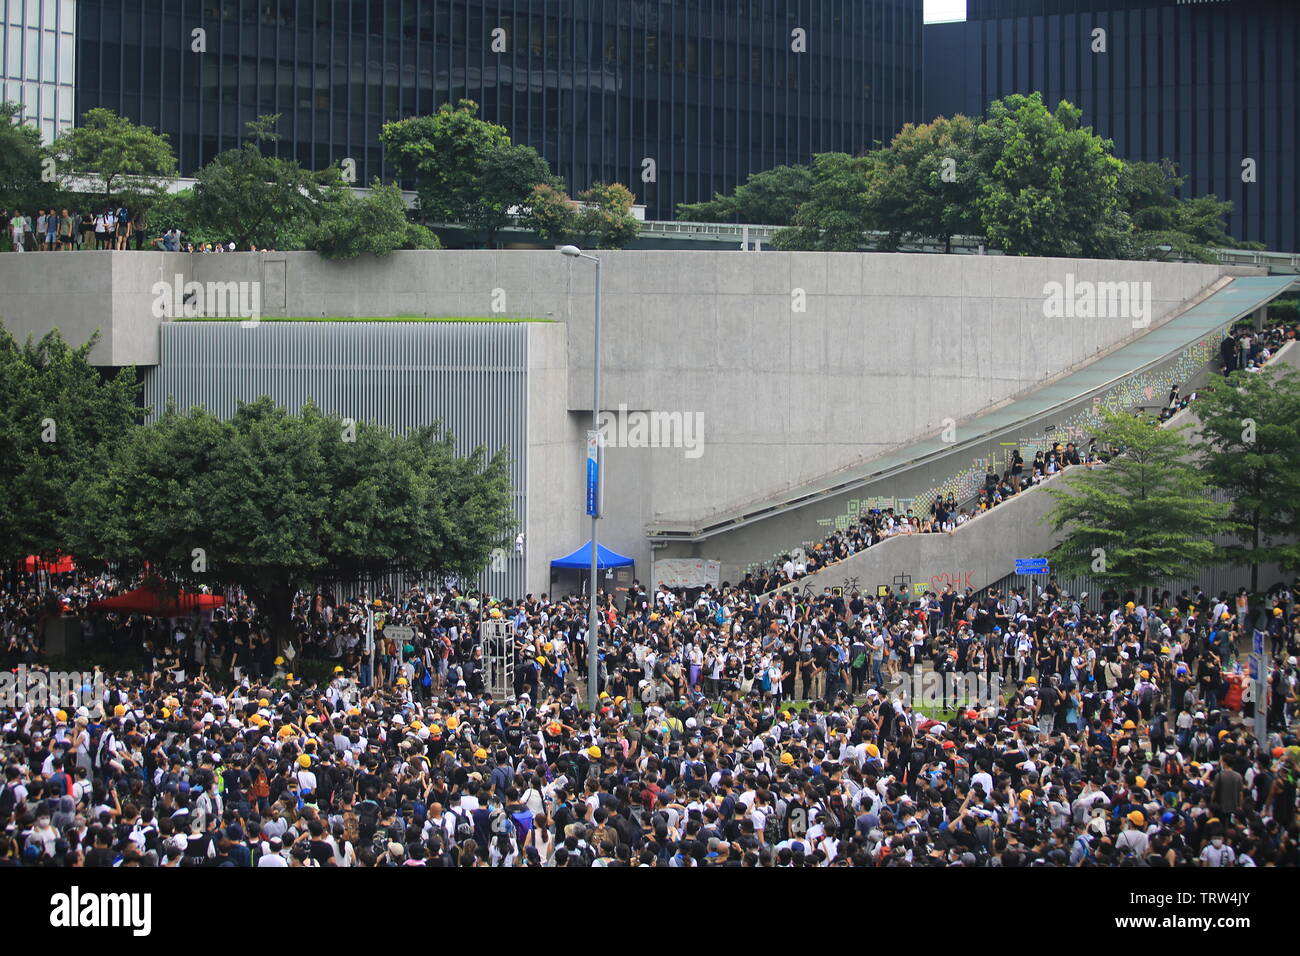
[924,0,1300,251]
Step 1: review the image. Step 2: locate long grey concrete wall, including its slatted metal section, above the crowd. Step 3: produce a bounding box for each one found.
[0,244,1258,592]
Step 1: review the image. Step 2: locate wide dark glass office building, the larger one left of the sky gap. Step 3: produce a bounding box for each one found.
[77,0,922,219]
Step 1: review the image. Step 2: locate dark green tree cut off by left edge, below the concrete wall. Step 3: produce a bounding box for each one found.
[0,325,139,562]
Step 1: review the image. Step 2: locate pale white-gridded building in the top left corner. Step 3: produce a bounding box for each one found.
[0,0,77,143]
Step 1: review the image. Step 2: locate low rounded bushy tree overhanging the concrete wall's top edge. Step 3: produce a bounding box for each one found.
[304,178,442,259]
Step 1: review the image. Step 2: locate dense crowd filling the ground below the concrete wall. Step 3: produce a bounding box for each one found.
[0,564,1300,868]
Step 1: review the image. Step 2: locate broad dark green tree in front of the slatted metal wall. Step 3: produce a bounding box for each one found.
[73,397,514,650]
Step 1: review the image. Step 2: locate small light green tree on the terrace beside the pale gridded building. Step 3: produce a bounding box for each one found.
[51,107,176,208]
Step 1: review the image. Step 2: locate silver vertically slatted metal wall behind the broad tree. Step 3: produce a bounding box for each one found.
[144,321,528,596]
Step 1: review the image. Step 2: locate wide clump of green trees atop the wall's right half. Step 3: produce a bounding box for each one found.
[696,94,1251,260]
